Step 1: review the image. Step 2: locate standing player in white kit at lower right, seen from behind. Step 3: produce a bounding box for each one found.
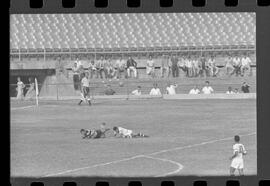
[230,135,247,176]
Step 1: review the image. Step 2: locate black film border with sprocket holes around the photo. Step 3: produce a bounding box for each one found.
[7,0,270,186]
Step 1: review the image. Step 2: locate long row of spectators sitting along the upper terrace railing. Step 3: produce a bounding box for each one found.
[72,52,252,83]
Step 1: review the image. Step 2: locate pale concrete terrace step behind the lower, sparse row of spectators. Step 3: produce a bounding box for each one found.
[41,76,256,98]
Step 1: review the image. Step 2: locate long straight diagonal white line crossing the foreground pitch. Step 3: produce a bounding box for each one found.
[43,132,256,177]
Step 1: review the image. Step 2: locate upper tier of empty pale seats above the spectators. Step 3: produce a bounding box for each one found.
[10,13,256,53]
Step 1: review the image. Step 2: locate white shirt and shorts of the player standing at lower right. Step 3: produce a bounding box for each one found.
[231,143,246,169]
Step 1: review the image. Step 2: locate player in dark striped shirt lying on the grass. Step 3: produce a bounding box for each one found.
[80,123,110,139]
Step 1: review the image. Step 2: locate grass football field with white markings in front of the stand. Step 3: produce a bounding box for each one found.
[10,99,257,177]
